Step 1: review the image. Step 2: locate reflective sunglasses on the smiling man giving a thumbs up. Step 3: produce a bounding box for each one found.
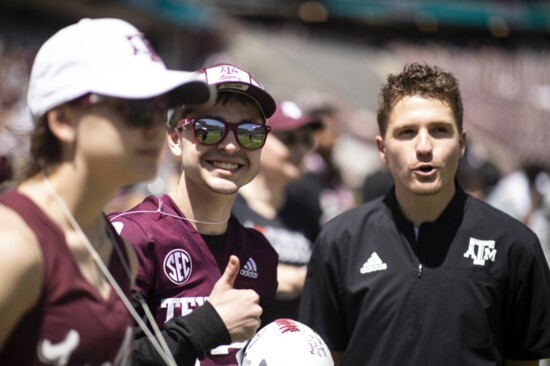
[178,118,271,150]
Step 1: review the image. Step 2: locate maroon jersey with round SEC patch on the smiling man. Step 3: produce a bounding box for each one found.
[109,195,278,365]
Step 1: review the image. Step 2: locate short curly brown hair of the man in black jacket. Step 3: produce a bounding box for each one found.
[377,63,464,136]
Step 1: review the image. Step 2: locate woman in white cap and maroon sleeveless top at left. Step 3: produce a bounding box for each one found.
[0,19,212,365]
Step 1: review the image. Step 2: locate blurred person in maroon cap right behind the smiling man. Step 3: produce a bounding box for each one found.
[233,100,322,322]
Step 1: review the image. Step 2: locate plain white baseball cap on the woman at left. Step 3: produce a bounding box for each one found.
[27,18,215,120]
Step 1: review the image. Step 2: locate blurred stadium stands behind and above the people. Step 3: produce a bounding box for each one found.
[0,0,550,182]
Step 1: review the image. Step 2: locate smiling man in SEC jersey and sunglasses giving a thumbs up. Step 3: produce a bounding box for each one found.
[109,64,278,365]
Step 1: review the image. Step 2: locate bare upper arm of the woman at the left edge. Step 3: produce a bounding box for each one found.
[0,213,44,351]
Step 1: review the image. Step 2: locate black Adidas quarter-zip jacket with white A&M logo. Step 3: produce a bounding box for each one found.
[299,183,550,366]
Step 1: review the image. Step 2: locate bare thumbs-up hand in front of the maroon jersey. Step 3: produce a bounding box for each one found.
[208,255,262,342]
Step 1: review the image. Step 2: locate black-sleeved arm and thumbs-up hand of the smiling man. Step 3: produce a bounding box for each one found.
[133,256,262,366]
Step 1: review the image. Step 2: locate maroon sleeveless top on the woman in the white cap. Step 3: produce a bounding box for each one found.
[0,191,133,366]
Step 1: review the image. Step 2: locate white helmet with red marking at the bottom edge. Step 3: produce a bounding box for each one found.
[237,319,334,366]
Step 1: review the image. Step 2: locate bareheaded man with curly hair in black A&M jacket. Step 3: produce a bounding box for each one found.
[299,63,550,366]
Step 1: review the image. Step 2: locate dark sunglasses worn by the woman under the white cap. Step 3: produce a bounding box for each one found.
[70,93,167,128]
